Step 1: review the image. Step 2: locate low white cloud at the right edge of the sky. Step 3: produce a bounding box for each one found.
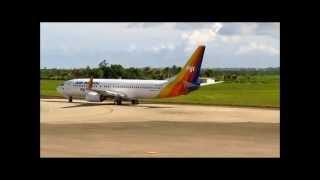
[236,42,280,55]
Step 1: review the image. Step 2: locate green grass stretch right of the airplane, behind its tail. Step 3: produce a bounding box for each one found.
[145,83,280,107]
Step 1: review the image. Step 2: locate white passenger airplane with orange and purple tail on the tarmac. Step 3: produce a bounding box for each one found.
[57,45,220,105]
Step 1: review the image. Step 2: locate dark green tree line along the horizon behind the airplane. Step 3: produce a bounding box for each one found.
[40,61,280,80]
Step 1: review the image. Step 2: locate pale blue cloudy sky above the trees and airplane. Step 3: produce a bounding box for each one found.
[40,22,280,68]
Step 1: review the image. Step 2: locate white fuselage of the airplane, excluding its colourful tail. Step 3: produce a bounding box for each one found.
[57,79,168,99]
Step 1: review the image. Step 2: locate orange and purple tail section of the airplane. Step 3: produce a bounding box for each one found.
[158,46,205,98]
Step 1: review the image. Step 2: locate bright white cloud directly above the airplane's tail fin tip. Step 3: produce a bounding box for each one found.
[181,23,222,51]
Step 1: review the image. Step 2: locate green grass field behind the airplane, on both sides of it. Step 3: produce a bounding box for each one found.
[41,75,280,107]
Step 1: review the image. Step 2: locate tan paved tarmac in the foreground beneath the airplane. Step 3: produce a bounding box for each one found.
[40,99,280,158]
